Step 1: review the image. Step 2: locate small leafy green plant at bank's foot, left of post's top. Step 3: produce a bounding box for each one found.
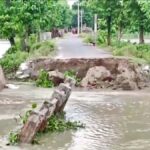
[36,70,54,88]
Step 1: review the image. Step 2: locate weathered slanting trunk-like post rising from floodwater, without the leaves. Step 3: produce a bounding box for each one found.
[19,79,75,143]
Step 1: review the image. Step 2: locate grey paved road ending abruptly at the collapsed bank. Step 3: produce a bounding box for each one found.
[56,34,112,59]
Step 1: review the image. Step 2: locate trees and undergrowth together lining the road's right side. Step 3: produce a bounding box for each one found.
[73,0,150,62]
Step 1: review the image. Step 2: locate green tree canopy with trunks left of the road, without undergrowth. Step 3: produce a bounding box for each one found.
[0,0,72,51]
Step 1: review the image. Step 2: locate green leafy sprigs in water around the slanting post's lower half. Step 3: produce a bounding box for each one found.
[8,103,85,145]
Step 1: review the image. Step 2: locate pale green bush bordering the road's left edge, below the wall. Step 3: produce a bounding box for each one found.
[30,41,56,57]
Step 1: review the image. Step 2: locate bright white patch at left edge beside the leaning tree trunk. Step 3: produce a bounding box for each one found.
[0,40,10,58]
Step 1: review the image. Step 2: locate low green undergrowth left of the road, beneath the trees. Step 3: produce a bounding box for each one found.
[0,41,56,77]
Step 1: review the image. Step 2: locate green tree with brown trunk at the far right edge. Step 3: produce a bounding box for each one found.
[124,0,150,44]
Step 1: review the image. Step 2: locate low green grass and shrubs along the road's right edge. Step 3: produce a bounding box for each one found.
[81,31,150,64]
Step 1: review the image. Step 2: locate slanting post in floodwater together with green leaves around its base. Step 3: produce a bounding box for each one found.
[9,78,83,144]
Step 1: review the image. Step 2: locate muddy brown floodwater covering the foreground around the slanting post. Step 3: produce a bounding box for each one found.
[0,85,150,150]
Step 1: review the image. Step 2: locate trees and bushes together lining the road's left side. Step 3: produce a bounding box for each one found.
[0,0,72,76]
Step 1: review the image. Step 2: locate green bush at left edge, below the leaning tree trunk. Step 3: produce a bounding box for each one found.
[0,47,28,73]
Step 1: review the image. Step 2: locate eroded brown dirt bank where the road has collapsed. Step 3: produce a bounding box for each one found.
[18,57,149,90]
